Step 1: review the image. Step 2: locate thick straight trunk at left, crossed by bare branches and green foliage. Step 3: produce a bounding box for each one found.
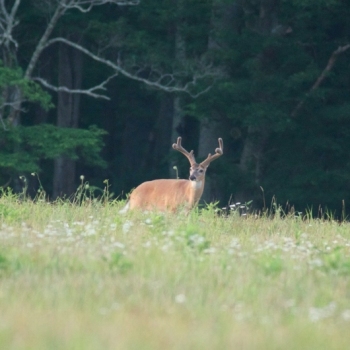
[53,40,82,198]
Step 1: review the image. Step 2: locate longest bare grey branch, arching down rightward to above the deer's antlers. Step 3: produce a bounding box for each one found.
[45,37,220,98]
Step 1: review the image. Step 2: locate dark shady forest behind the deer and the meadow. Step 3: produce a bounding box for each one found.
[0,0,350,216]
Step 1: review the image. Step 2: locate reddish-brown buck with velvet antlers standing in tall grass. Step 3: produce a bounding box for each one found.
[120,137,224,213]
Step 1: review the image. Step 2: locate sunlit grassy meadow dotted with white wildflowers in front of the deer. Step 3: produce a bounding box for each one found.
[0,195,350,350]
